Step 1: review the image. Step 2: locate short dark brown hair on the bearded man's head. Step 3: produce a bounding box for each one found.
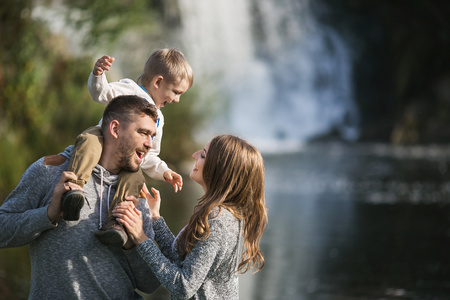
[102,95,158,132]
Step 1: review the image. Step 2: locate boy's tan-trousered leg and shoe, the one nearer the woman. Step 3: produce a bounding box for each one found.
[95,170,145,247]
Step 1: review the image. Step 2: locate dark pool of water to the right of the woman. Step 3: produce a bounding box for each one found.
[241,143,450,300]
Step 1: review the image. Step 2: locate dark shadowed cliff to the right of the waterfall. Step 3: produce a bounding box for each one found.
[311,0,450,144]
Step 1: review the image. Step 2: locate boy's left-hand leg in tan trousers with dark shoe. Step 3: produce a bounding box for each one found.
[62,126,103,221]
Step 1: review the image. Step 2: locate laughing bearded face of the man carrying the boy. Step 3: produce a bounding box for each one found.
[118,116,156,172]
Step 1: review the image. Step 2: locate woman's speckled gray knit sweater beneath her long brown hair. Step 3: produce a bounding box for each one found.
[137,208,240,300]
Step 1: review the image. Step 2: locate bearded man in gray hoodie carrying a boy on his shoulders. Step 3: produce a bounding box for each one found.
[0,96,159,300]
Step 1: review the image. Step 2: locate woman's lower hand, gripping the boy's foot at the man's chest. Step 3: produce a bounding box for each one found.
[112,196,148,245]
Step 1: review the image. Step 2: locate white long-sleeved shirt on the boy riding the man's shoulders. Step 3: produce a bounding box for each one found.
[88,72,170,181]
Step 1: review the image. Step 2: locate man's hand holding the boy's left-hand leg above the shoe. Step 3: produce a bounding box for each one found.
[47,171,83,222]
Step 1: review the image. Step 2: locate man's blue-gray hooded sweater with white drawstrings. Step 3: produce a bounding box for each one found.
[0,147,159,300]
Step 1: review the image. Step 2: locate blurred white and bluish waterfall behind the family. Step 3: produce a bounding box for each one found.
[178,0,359,151]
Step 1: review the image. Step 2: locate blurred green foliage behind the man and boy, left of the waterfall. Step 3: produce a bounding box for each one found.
[0,0,199,204]
